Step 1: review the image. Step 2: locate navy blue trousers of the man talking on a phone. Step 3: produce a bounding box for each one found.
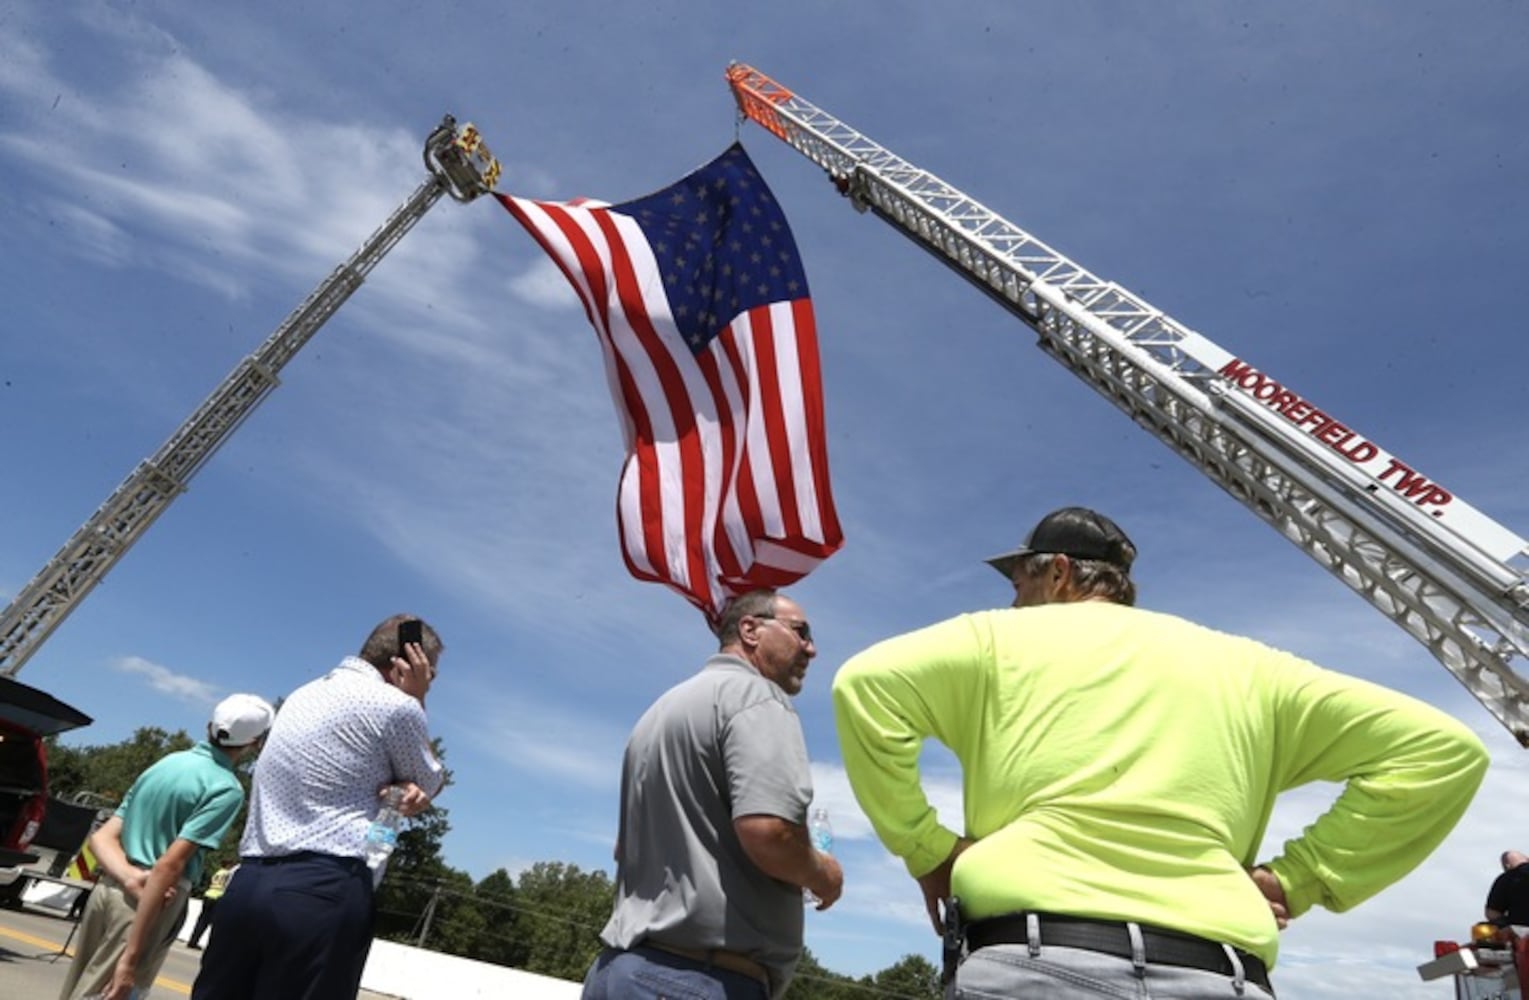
[191,853,373,1000]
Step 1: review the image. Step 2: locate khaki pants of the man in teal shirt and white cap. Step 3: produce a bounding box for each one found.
[58,875,191,1000]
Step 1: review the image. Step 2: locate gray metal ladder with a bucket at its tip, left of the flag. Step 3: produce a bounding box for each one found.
[0,115,500,677]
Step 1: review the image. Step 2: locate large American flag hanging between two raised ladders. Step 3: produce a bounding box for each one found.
[497,144,844,619]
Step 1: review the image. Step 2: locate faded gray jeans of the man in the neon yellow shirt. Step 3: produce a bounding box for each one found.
[954,943,1272,1000]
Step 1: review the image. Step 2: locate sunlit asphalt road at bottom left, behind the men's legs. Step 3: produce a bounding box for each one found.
[0,908,388,1000]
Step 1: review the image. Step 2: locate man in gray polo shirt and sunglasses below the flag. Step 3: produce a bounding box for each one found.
[584,590,844,1000]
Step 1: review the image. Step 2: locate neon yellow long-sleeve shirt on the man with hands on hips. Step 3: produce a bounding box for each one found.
[833,601,1488,965]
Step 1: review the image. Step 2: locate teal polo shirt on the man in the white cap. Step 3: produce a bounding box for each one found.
[116,740,245,885]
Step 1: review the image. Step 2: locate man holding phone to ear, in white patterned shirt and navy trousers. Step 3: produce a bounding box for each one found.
[191,615,445,1000]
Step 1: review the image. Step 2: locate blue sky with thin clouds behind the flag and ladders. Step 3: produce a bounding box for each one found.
[0,0,1529,997]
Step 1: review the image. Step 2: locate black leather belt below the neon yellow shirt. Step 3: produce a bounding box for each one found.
[965,913,1274,994]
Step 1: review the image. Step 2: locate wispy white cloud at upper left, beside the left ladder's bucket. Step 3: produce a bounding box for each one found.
[0,28,422,305]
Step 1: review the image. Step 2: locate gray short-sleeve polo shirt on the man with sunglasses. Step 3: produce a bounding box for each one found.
[601,654,812,997]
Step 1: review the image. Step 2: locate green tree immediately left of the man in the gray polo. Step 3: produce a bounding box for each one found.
[515,861,616,980]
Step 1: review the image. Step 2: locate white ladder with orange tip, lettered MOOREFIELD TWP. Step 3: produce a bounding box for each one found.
[728,63,1529,746]
